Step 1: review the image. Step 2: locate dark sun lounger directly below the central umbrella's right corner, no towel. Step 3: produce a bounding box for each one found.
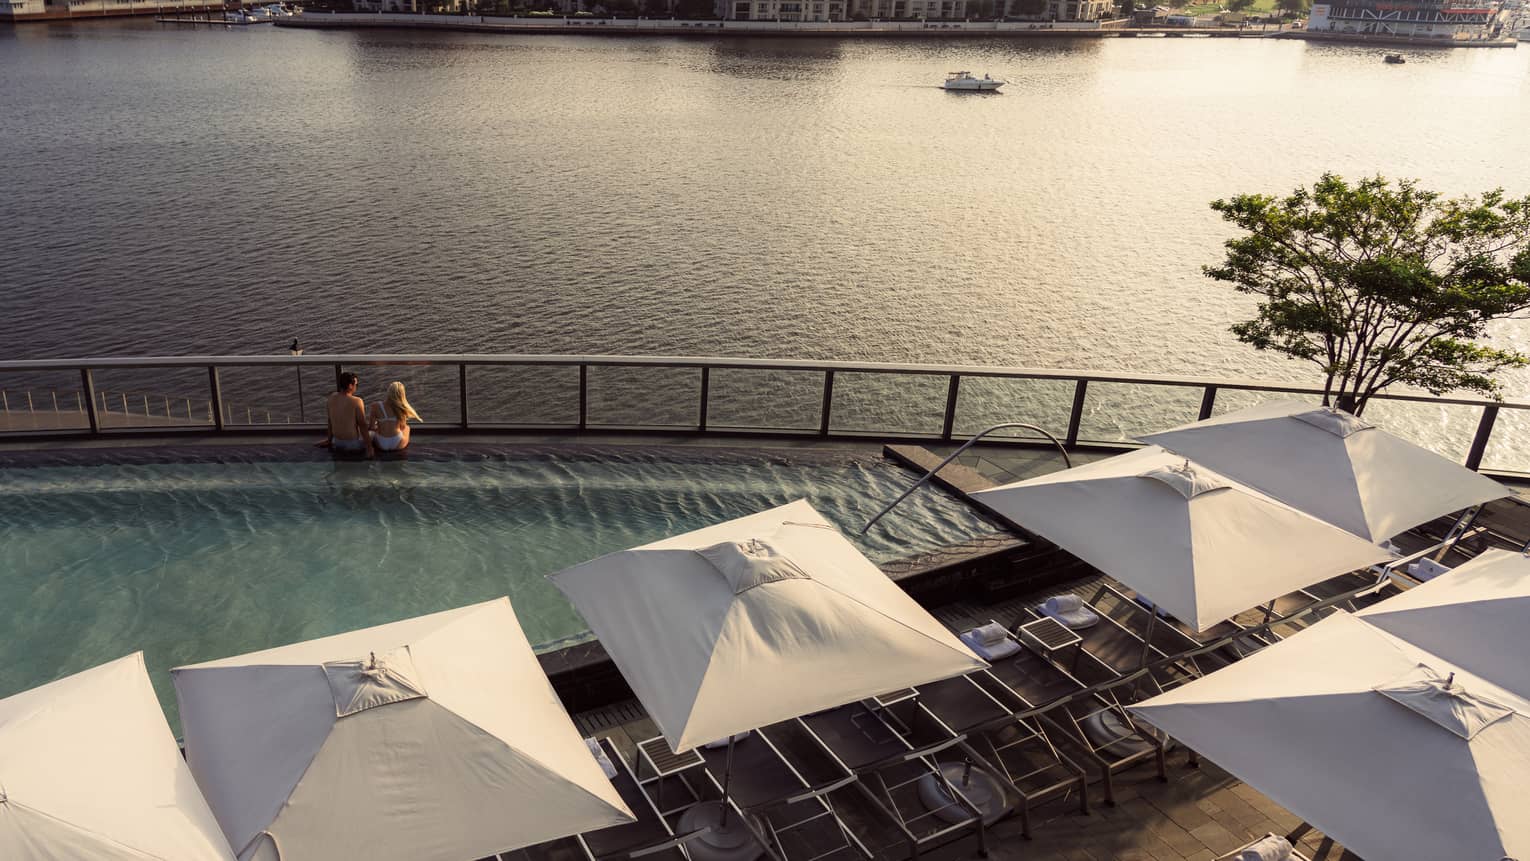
[918,676,1089,837]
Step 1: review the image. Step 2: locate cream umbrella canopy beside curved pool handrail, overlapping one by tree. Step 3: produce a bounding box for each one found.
[973,447,1391,630]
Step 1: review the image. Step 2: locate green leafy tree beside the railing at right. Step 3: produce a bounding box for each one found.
[1204,174,1530,414]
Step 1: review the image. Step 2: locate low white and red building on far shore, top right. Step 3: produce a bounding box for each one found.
[1307,0,1501,40]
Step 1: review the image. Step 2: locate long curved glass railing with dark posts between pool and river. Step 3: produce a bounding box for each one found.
[0,355,1530,473]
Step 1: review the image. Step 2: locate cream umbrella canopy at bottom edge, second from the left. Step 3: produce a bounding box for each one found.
[173,598,632,861]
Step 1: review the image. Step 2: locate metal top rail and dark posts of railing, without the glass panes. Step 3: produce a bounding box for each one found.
[0,353,1530,469]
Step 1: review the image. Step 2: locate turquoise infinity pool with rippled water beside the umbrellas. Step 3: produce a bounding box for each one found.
[0,447,995,713]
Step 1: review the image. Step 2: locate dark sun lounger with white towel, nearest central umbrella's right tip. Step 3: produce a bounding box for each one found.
[970,627,1167,804]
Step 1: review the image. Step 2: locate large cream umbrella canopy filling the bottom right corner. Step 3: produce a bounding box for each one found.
[1131,613,1530,861]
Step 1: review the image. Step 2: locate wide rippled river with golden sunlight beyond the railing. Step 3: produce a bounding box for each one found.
[0,21,1530,383]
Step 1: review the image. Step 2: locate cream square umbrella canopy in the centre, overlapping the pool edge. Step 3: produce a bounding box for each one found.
[552,500,987,751]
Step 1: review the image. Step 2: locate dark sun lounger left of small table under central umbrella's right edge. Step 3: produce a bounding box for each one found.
[796,691,985,856]
